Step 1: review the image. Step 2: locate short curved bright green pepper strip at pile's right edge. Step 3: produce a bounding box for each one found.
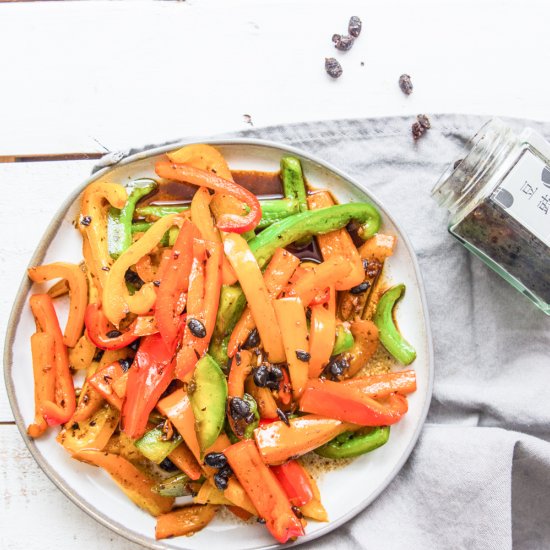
[373,284,416,365]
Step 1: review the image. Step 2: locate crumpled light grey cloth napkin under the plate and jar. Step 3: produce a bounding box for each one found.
[102,115,550,550]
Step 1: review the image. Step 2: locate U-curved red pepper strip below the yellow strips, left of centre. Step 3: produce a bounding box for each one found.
[84,304,158,350]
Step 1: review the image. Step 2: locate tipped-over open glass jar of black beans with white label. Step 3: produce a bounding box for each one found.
[432,119,550,315]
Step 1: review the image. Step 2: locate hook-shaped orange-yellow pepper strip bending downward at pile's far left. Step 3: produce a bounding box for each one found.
[28,262,88,348]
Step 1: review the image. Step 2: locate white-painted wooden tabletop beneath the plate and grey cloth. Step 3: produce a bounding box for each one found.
[0,0,550,550]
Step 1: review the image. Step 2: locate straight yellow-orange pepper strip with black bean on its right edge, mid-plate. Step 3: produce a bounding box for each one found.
[273,298,311,400]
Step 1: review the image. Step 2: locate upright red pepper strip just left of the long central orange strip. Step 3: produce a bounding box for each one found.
[155,220,200,346]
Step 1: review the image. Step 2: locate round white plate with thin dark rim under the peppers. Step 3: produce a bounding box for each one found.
[4,140,433,550]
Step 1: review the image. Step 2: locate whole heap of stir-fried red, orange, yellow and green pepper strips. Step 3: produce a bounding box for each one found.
[23,144,416,543]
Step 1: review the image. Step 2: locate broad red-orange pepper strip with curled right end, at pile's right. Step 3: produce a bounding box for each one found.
[300,379,408,426]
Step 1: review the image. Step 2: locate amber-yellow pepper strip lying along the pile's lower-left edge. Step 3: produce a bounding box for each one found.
[73,450,174,516]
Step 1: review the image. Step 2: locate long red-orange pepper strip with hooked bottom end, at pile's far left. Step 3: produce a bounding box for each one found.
[29,294,76,426]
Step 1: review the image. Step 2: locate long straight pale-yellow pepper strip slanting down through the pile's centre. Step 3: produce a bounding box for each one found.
[223,234,286,363]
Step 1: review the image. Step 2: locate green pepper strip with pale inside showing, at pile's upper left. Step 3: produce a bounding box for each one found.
[107,178,158,259]
